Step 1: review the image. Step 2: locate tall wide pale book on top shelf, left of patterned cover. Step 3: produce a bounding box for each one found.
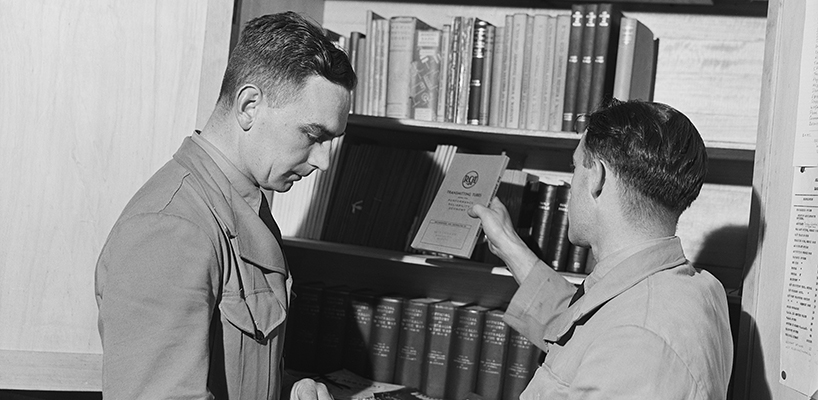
[386,16,436,118]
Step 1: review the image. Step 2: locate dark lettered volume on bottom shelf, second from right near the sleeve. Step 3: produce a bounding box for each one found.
[474,310,511,400]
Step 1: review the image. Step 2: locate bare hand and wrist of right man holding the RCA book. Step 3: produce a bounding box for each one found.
[469,197,539,282]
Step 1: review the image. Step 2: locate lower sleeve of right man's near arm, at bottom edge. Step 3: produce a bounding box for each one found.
[568,326,696,400]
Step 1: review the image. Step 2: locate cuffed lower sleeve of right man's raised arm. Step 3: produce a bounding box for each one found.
[504,261,576,351]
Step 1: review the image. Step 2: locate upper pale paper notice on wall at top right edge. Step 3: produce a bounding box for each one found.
[793,1,818,167]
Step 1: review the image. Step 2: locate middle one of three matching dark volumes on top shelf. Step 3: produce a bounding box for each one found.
[573,4,599,133]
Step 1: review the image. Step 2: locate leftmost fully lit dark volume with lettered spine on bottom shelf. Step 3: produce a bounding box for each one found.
[369,295,403,382]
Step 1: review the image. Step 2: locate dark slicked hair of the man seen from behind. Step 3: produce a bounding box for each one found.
[583,99,707,219]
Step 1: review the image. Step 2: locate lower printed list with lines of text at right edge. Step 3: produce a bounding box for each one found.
[779,167,818,395]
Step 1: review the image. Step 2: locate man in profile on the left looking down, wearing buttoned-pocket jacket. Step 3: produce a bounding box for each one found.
[96,13,356,400]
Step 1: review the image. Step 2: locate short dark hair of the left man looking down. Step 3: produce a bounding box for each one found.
[219,11,357,107]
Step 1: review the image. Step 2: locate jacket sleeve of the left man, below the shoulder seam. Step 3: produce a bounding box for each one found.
[97,214,220,399]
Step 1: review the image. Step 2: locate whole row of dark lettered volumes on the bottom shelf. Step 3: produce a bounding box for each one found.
[285,283,543,400]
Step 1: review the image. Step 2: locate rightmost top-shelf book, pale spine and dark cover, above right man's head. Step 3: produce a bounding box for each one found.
[613,17,658,101]
